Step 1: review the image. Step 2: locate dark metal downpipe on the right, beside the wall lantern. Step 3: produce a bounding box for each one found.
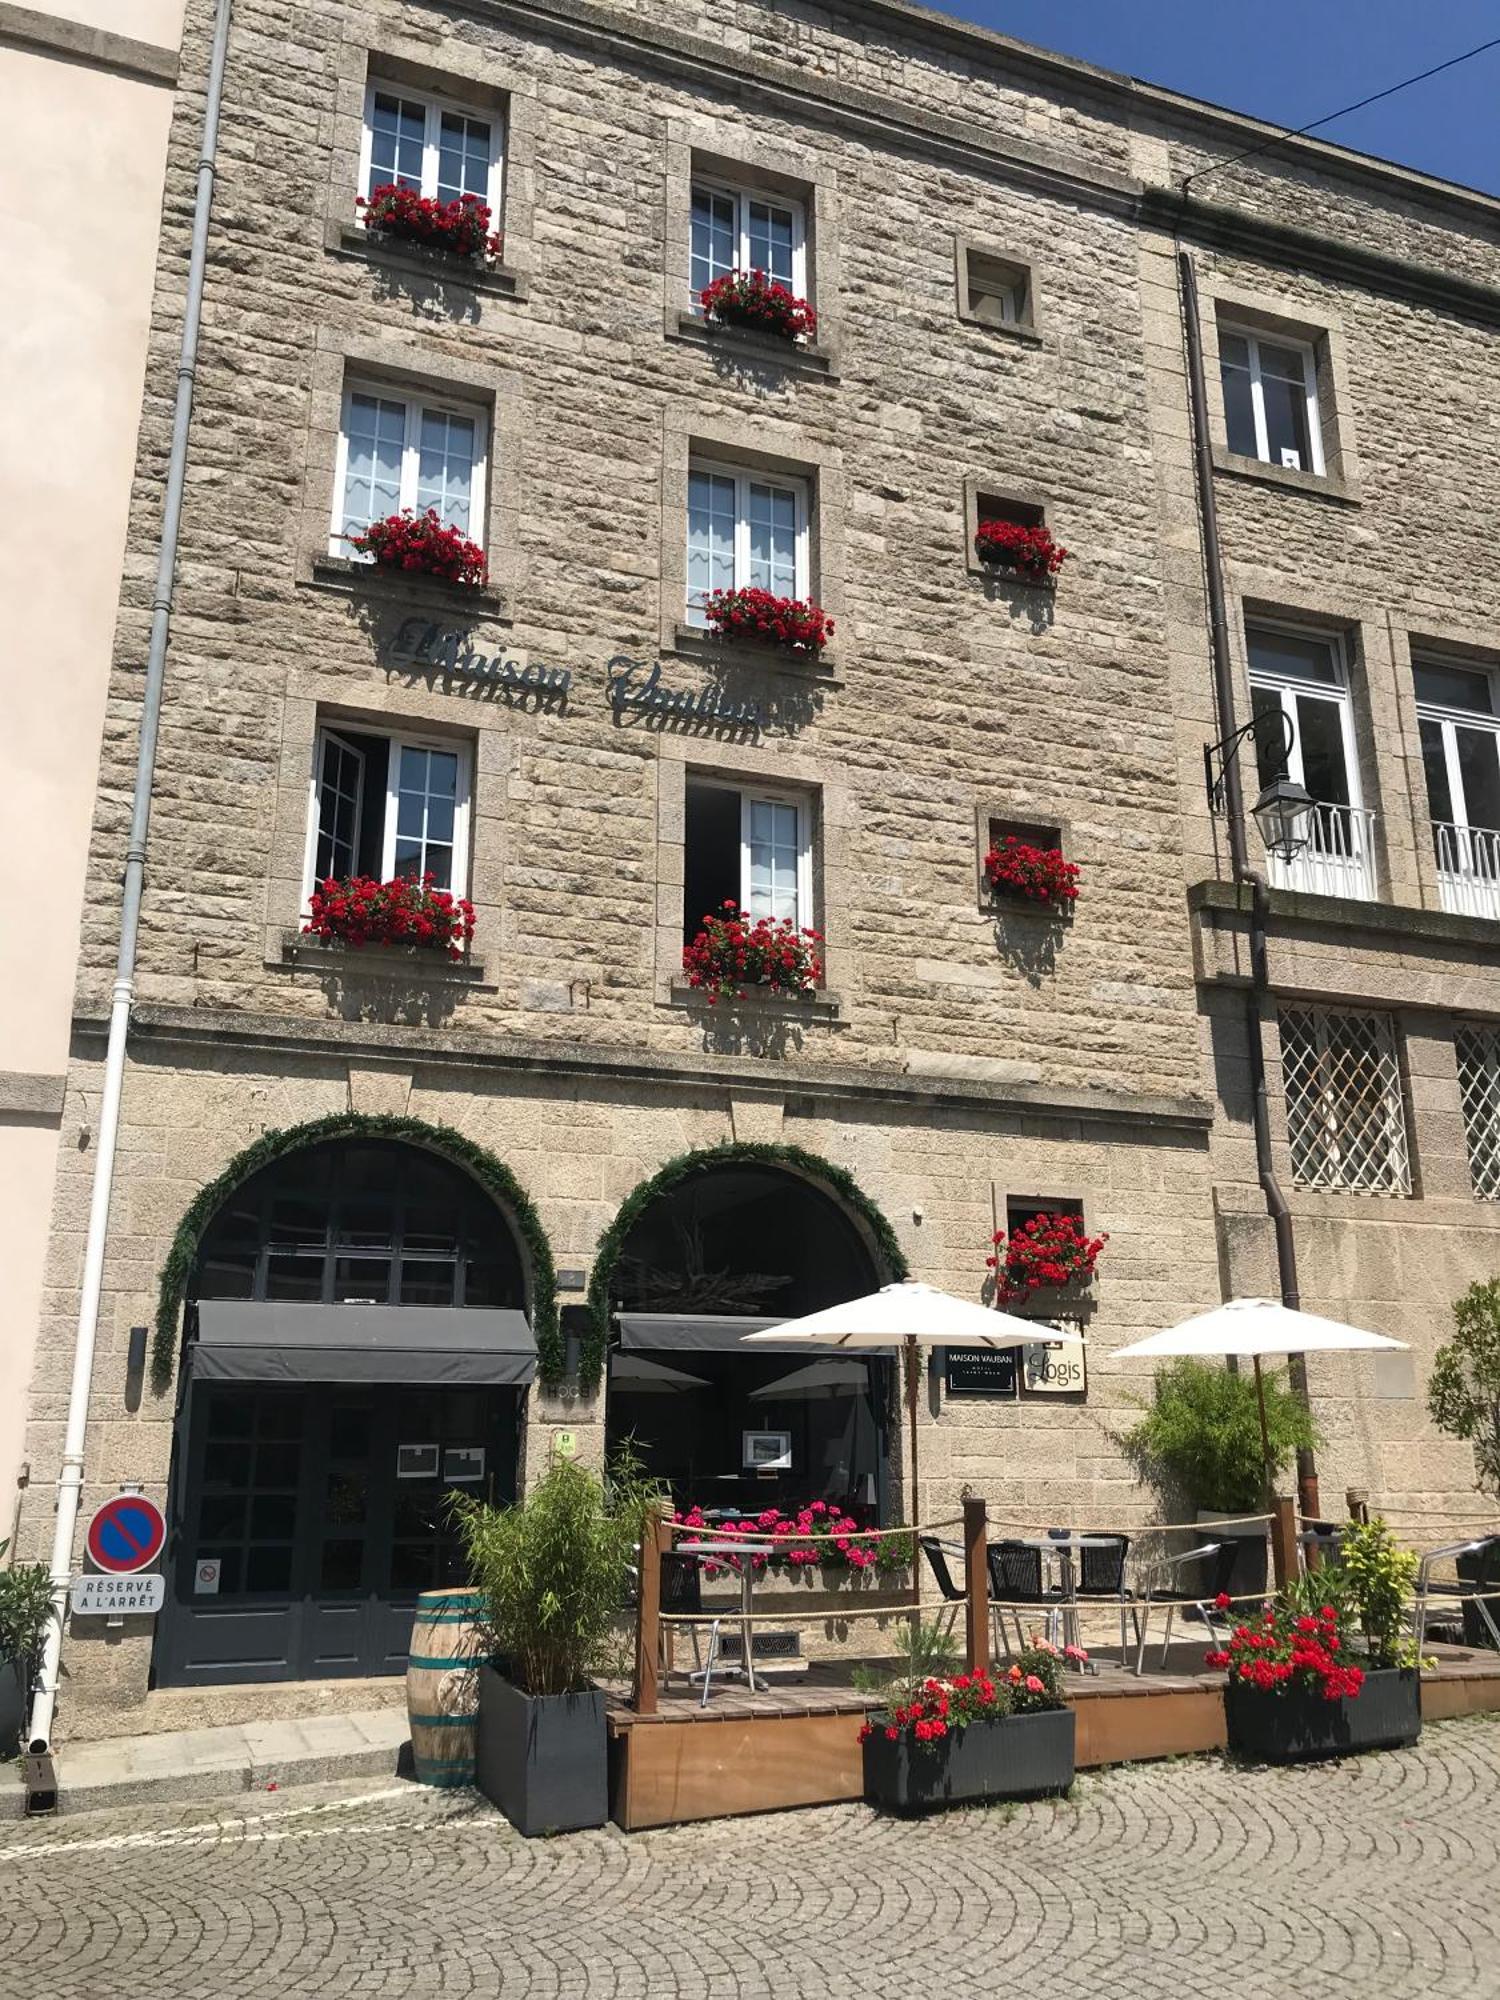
[1178,250,1320,1518]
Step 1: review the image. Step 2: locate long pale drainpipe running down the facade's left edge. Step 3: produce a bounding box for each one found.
[28,0,232,1752]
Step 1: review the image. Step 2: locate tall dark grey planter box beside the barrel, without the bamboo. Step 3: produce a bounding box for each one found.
[474,1666,610,1834]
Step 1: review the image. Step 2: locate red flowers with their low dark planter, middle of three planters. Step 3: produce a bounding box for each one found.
[860,1628,1088,1812]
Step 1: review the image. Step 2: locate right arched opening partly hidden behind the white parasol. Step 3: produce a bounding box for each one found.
[604,1148,900,1522]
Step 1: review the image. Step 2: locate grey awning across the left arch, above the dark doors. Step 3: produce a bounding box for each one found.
[188,1298,536,1388]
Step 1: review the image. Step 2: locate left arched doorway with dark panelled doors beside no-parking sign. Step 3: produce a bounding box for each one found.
[156,1134,536,1686]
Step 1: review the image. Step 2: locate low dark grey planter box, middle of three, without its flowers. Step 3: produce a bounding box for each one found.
[864,1708,1074,1812]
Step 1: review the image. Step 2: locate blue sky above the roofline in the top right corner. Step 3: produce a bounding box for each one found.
[928,0,1500,194]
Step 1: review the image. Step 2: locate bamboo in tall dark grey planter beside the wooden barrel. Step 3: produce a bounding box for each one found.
[456,1458,654,1834]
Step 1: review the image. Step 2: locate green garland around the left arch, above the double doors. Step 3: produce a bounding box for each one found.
[152,1112,562,1388]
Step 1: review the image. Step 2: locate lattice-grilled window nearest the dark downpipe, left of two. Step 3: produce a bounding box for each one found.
[1280,1008,1412,1194]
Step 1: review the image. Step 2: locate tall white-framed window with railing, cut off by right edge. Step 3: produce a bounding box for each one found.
[1412,658,1500,916]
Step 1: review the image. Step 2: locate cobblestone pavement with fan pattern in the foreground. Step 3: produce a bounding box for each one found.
[0,1718,1500,2000]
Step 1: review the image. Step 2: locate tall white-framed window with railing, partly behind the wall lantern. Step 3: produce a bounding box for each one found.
[1244,624,1374,898]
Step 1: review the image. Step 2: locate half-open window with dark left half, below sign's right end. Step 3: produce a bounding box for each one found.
[682,778,814,944]
